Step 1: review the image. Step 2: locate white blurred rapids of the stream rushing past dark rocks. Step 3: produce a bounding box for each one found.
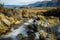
[1,19,34,40]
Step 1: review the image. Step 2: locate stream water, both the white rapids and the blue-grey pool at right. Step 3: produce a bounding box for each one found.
[0,19,60,40]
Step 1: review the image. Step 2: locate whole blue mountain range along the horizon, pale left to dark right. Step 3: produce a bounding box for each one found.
[4,1,60,8]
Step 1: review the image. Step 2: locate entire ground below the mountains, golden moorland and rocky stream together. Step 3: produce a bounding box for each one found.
[0,7,60,40]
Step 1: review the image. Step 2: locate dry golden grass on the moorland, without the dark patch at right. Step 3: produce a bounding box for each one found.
[0,7,59,34]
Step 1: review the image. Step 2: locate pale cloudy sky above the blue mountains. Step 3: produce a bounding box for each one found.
[0,0,51,5]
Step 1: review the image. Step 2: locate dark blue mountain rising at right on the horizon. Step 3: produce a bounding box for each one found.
[28,1,60,7]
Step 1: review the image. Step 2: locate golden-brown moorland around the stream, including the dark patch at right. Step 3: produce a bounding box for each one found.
[0,5,60,40]
